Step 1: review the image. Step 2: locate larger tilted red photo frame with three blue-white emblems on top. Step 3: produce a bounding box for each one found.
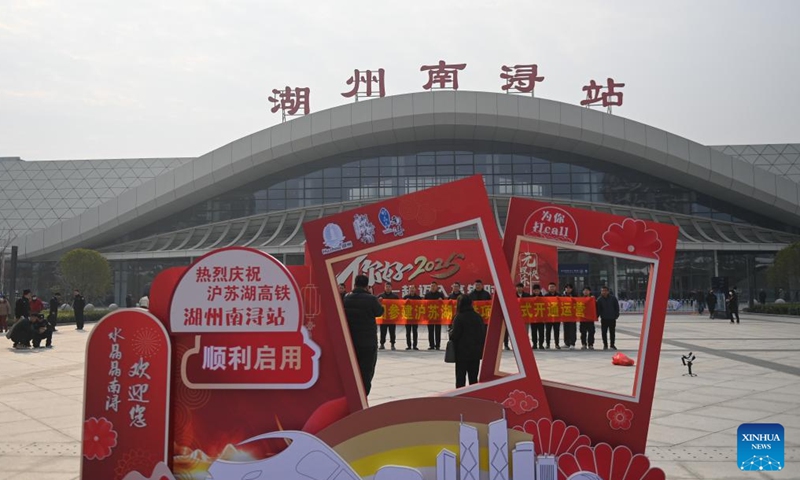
[303,176,550,424]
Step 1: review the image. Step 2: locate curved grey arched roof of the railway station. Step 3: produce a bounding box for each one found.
[14,91,800,260]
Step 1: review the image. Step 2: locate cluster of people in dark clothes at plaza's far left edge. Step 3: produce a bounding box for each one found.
[0,290,86,349]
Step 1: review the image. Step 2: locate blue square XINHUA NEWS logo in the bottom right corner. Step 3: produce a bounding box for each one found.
[736,423,784,472]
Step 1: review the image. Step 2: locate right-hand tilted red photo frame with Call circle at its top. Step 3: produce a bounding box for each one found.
[496,198,678,453]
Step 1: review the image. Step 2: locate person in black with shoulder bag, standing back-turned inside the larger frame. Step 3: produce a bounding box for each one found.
[448,295,486,388]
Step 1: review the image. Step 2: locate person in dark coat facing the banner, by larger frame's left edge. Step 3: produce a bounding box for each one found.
[344,275,383,395]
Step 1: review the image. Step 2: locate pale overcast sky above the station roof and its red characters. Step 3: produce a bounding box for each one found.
[0,0,800,160]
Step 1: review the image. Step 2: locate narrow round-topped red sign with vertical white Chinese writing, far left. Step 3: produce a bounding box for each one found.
[81,310,171,479]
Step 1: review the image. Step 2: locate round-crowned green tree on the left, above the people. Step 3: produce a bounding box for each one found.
[58,248,112,299]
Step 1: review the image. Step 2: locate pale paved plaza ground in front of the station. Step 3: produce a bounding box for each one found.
[0,315,800,480]
